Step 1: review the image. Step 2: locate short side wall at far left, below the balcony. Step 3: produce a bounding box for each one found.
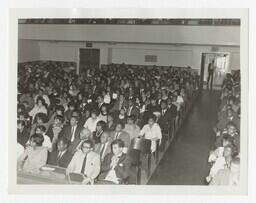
[18,39,40,63]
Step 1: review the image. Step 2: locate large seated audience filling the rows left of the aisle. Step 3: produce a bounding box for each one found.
[17,62,200,184]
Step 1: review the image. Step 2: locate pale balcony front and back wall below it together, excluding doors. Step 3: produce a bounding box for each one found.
[19,25,240,70]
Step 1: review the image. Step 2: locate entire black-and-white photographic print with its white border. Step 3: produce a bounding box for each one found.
[4,9,252,198]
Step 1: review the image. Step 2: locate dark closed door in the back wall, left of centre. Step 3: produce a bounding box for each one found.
[79,48,100,73]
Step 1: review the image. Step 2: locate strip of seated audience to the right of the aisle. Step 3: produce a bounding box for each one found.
[206,71,241,185]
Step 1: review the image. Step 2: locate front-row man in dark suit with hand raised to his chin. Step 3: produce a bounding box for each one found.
[99,139,131,184]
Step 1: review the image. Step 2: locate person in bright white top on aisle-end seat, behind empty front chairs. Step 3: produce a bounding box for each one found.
[139,114,162,152]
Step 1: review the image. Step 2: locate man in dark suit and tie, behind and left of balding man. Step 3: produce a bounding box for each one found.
[59,116,83,151]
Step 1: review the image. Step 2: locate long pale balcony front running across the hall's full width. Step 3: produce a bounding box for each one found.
[18,24,240,46]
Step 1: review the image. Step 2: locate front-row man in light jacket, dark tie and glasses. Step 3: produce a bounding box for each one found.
[66,140,100,184]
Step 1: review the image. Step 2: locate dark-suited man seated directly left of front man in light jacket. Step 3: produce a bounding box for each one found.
[47,137,72,168]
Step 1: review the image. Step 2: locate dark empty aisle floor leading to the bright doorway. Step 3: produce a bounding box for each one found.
[148,91,219,185]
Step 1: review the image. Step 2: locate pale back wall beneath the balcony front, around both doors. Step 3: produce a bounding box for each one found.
[19,40,240,70]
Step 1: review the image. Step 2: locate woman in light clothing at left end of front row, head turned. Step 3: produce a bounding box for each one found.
[17,134,48,173]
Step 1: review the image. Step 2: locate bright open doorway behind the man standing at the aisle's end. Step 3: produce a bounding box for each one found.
[200,52,230,89]
